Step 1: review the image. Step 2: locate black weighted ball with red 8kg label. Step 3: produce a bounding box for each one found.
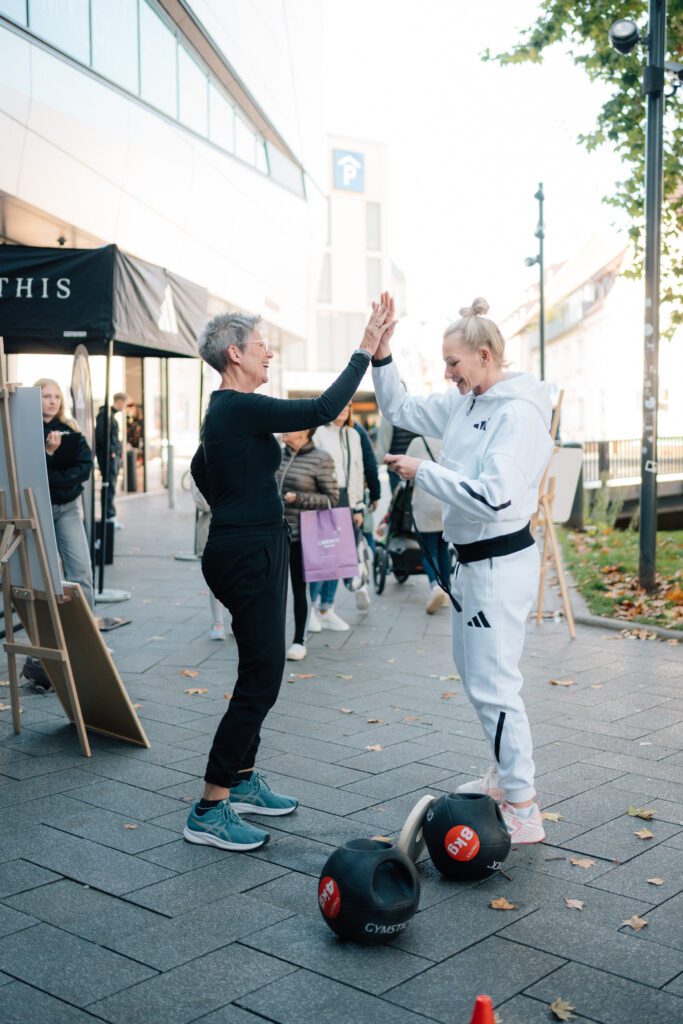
[424,793,510,882]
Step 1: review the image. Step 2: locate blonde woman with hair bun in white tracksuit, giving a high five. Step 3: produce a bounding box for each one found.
[373,296,552,843]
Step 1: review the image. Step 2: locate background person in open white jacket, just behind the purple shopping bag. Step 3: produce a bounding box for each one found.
[308,402,370,633]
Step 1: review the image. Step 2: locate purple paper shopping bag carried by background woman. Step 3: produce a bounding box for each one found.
[301,508,358,583]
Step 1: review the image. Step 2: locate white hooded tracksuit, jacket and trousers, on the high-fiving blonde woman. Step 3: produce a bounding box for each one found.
[373,362,553,803]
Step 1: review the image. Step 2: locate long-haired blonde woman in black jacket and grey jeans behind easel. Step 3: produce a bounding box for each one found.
[34,377,95,611]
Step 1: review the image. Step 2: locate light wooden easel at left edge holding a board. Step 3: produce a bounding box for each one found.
[0,356,91,758]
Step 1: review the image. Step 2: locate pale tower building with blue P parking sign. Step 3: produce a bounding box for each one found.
[284,136,405,419]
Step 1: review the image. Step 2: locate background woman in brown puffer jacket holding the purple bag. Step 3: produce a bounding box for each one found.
[278,429,339,662]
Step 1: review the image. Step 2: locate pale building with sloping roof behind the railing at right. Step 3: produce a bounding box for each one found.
[501,234,683,441]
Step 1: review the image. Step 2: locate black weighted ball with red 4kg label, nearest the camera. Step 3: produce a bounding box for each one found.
[317,839,420,945]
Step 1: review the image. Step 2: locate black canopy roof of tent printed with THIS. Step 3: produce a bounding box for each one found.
[0,245,207,357]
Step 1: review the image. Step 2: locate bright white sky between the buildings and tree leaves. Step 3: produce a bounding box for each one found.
[323,0,624,319]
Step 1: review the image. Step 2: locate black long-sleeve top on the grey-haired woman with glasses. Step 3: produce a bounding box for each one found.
[190,351,370,526]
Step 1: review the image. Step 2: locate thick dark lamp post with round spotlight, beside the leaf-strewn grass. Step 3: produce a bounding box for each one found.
[609,0,677,591]
